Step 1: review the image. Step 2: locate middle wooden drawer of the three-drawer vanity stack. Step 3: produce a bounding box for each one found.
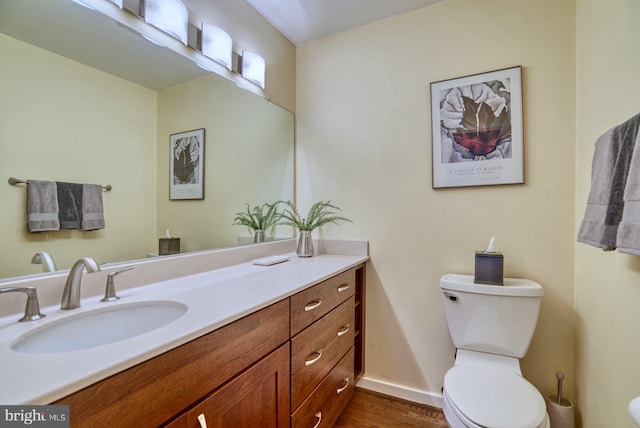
[291,297,355,409]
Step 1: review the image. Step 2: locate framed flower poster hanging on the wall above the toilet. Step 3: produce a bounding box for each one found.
[431,66,524,189]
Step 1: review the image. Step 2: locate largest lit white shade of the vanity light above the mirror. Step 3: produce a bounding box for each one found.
[144,0,189,46]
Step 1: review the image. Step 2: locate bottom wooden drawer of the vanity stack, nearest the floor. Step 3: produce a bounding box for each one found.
[291,348,355,428]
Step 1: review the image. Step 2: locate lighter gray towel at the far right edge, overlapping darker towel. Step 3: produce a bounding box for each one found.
[617,132,640,256]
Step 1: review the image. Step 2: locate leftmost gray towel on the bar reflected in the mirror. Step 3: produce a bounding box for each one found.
[27,180,60,232]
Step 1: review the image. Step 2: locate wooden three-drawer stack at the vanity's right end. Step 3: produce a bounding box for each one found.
[291,265,364,428]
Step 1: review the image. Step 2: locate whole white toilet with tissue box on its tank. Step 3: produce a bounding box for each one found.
[440,274,549,428]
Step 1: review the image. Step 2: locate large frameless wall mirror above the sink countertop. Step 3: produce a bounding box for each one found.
[0,0,294,278]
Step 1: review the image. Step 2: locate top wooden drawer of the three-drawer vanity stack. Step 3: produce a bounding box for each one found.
[291,269,356,336]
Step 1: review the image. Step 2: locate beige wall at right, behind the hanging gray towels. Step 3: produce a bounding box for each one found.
[575,0,640,428]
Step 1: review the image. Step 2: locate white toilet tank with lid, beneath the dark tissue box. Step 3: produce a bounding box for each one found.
[440,274,543,358]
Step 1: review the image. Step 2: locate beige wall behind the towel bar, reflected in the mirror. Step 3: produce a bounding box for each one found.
[0,34,157,278]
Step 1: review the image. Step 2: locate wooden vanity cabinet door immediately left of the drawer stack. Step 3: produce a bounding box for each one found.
[187,343,290,428]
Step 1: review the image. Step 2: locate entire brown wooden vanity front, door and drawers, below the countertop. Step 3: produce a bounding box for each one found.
[52,264,365,428]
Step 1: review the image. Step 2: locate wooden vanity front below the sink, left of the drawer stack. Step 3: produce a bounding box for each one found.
[53,300,290,428]
